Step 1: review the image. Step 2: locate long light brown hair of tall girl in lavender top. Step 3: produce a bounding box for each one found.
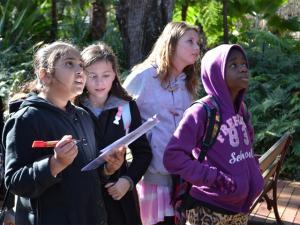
[132,22,199,96]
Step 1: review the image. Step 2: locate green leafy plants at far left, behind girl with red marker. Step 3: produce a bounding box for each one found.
[0,0,50,97]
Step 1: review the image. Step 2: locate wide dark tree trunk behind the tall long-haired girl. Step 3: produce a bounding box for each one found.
[116,0,175,67]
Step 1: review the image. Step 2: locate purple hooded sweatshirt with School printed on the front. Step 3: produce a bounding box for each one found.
[163,44,263,213]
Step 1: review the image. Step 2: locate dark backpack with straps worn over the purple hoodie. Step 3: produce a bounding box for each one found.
[171,95,250,225]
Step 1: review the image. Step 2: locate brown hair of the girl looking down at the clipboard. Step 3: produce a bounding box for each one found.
[81,42,132,101]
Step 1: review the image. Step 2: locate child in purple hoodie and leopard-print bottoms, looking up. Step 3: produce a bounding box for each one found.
[163,44,263,225]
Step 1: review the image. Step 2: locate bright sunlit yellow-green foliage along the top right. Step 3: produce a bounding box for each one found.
[173,0,300,47]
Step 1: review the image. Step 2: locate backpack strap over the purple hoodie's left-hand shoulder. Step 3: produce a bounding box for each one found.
[193,95,221,162]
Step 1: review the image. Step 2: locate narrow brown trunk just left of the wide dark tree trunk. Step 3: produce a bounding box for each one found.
[90,0,107,41]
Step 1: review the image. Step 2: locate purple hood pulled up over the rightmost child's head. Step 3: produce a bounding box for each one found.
[201,44,248,113]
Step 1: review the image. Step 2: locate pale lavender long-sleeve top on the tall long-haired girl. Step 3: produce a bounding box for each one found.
[124,65,192,185]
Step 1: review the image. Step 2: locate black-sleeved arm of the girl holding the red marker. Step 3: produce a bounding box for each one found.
[3,117,60,198]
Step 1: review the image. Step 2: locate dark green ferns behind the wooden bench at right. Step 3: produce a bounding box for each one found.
[239,30,300,179]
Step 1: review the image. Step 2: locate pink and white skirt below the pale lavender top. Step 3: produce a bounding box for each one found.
[136,181,174,225]
